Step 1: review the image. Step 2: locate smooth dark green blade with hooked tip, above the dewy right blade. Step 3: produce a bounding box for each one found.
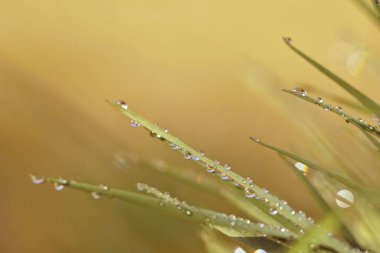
[283,38,380,115]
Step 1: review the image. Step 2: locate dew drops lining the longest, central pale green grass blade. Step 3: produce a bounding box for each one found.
[115,100,314,229]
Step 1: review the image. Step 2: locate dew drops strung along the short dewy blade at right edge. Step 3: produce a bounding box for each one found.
[290,87,380,132]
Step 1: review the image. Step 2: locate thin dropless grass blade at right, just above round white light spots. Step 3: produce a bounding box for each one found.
[250,137,380,204]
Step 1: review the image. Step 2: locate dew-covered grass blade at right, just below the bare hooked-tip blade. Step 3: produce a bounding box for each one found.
[283,89,380,137]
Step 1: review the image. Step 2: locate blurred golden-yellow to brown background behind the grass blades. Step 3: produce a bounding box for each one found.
[0,0,380,253]
